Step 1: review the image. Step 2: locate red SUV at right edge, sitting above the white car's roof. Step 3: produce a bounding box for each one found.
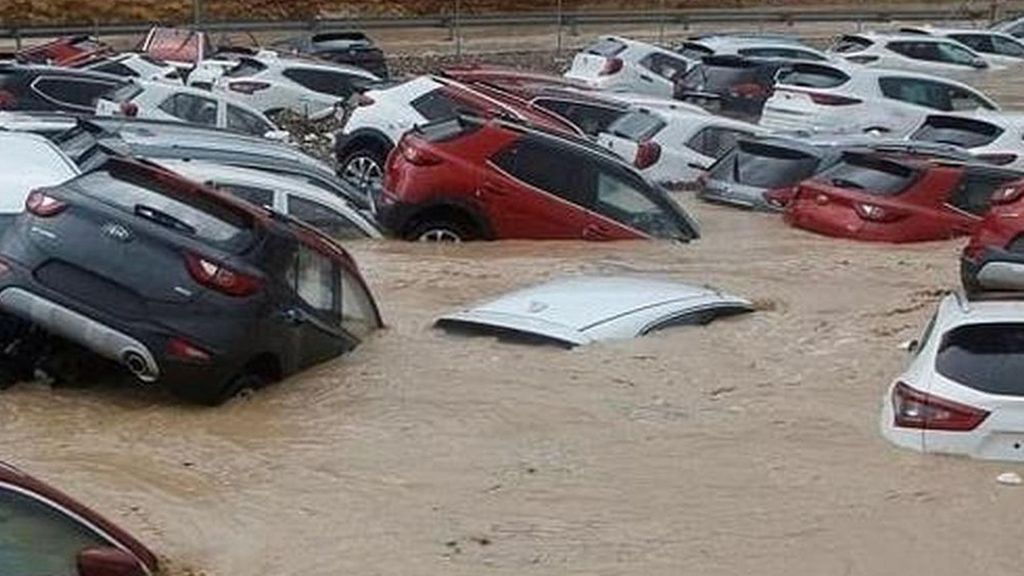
[961,180,1024,294]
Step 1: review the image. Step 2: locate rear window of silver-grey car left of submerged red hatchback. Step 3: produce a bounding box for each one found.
[711,141,820,189]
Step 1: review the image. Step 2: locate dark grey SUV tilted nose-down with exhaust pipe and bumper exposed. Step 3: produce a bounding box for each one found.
[0,157,381,405]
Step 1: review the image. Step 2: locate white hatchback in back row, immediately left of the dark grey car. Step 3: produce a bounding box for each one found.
[565,36,696,97]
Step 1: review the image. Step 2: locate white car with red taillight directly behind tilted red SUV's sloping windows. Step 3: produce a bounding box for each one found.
[597,108,765,186]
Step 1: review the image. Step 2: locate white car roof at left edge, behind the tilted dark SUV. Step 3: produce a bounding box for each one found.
[0,132,80,212]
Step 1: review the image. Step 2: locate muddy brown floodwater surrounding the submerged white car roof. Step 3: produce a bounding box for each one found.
[9,66,1024,576]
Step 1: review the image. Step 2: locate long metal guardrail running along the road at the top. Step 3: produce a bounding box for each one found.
[0,5,1024,43]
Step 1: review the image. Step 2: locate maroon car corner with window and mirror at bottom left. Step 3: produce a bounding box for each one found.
[0,461,158,576]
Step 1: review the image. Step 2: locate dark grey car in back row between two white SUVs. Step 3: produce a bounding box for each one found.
[675,55,787,121]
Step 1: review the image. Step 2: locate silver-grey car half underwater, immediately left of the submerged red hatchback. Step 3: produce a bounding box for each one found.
[697,134,974,211]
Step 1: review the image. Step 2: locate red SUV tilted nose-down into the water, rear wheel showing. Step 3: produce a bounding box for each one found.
[374,116,698,242]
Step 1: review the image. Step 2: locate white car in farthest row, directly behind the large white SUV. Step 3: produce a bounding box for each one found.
[829,32,991,76]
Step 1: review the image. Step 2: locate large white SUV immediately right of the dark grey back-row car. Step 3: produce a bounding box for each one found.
[760,63,999,137]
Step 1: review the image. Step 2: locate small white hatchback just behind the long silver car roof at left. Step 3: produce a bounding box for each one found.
[96,81,288,139]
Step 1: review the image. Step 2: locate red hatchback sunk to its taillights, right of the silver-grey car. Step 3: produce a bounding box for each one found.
[785,152,1022,242]
